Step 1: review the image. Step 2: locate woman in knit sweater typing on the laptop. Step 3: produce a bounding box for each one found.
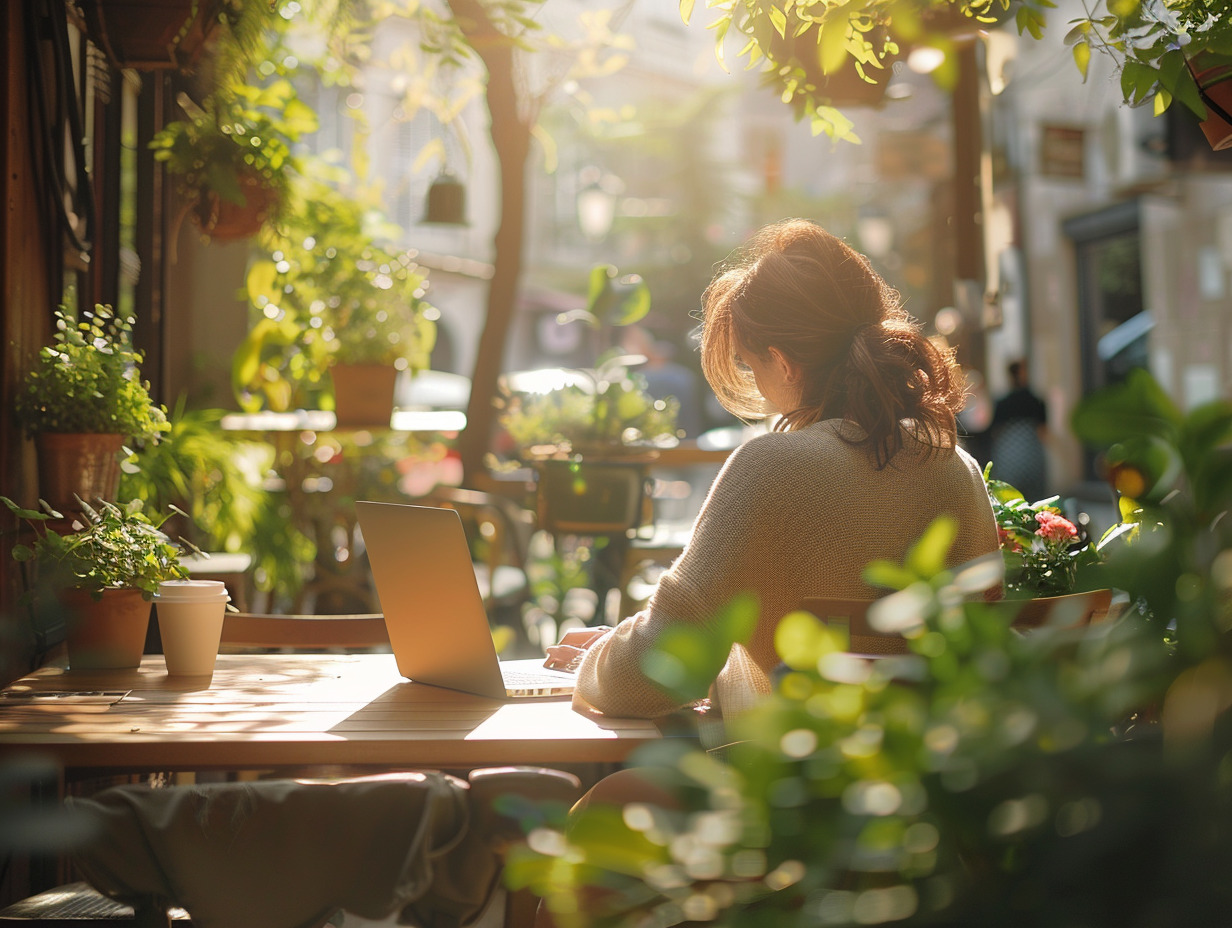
[548,219,997,717]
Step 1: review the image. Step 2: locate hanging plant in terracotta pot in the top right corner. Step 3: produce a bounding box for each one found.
[1066,0,1232,150]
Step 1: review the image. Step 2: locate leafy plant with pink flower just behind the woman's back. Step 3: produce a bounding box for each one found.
[984,461,1099,596]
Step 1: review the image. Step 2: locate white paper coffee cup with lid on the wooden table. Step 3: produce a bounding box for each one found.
[154,580,230,675]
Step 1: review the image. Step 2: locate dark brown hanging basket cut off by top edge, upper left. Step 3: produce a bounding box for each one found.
[81,0,223,71]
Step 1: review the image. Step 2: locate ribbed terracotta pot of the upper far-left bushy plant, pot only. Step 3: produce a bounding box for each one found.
[34,431,124,515]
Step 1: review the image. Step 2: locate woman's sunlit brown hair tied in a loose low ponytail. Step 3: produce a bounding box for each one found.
[701,219,965,468]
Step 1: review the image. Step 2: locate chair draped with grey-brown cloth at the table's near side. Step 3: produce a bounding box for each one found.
[0,768,580,928]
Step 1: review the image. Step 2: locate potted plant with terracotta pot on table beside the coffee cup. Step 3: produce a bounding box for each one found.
[0,497,188,670]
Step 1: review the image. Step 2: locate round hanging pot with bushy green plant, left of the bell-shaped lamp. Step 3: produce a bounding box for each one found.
[150,78,318,242]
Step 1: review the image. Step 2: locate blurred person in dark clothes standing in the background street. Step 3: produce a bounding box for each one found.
[988,359,1048,503]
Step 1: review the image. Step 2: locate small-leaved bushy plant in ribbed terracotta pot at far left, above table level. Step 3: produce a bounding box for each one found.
[16,304,169,511]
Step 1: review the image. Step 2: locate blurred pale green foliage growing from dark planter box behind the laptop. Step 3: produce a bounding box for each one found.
[500,357,680,454]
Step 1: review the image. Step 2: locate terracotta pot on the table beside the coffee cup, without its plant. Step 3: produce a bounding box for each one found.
[62,589,150,670]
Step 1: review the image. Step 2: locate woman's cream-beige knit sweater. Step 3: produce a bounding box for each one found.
[577,419,997,718]
